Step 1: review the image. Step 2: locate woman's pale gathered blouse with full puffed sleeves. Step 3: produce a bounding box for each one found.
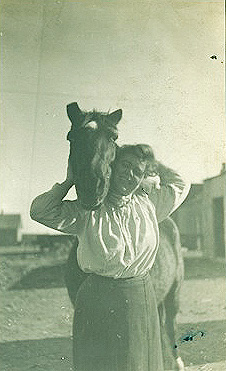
[30,183,189,278]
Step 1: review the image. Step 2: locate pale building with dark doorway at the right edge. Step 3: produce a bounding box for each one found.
[173,164,226,258]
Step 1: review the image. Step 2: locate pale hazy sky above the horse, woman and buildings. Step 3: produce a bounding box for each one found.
[0,0,225,233]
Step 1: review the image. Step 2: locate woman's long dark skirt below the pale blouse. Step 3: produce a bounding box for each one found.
[73,274,163,371]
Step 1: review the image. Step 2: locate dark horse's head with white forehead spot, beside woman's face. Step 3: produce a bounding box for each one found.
[67,103,122,210]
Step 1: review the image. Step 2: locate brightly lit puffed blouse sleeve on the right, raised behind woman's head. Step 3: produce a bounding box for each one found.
[143,167,190,222]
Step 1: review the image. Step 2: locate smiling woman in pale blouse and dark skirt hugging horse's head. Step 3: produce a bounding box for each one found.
[31,145,187,371]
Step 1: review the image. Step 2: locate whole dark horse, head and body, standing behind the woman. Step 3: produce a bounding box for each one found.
[65,103,183,369]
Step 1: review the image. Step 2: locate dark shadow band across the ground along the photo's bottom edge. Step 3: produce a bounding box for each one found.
[0,321,226,371]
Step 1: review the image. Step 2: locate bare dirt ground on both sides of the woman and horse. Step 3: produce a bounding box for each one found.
[0,250,226,371]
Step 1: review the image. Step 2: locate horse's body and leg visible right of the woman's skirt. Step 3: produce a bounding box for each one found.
[150,217,184,371]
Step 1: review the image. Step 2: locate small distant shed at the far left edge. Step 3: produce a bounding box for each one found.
[0,214,22,246]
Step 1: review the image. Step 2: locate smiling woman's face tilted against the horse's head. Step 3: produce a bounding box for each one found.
[111,153,146,196]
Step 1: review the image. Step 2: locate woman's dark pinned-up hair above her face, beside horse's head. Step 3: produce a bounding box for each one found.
[116,144,156,177]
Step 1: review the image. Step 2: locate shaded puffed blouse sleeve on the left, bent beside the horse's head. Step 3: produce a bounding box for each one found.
[30,183,82,234]
